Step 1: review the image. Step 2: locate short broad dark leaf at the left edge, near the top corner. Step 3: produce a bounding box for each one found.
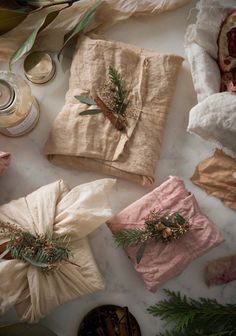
[0,8,27,35]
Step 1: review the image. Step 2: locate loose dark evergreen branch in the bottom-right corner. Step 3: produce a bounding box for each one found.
[148,289,236,336]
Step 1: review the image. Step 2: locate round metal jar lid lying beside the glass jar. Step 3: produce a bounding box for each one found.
[24,51,56,84]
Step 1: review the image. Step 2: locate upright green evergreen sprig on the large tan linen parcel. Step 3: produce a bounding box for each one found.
[108,66,128,117]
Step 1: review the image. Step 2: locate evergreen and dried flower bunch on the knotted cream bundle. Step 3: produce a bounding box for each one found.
[0,222,72,271]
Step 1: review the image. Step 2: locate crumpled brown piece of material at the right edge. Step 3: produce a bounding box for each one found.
[191,149,236,210]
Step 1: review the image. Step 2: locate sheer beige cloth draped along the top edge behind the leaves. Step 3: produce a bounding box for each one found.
[0,0,190,61]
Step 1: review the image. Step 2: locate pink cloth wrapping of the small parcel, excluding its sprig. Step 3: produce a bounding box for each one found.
[107,176,223,292]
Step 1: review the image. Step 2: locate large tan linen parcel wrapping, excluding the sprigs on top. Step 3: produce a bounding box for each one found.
[45,37,183,187]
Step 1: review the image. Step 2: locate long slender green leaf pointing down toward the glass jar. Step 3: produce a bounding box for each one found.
[9,9,61,69]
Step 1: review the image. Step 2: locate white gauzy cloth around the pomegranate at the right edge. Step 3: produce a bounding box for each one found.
[185,0,236,152]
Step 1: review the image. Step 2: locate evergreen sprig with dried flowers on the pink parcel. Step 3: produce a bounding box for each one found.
[113,210,189,263]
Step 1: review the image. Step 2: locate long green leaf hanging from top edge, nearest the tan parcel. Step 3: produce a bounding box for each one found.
[57,0,102,59]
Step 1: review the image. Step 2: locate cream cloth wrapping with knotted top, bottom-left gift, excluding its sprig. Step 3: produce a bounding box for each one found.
[0,179,114,322]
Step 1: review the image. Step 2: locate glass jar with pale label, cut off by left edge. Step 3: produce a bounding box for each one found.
[0,71,39,137]
